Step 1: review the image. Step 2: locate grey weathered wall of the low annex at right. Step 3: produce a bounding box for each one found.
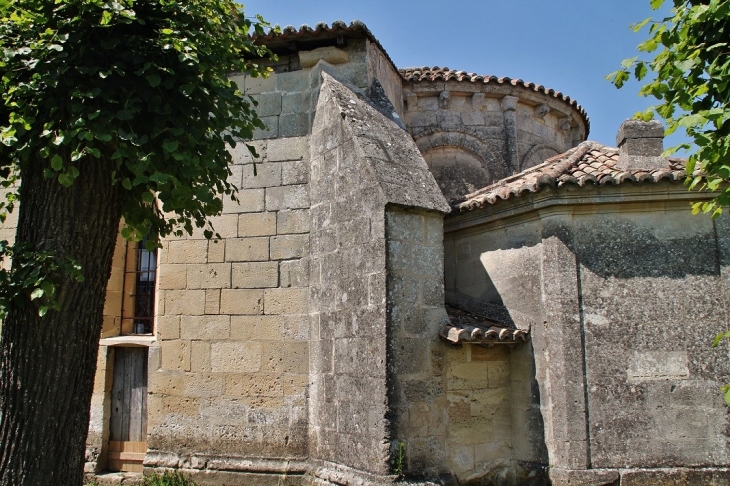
[446,184,730,484]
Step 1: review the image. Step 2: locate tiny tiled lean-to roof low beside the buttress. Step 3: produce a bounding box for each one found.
[439,305,530,344]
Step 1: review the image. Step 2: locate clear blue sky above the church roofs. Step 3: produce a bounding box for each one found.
[243,0,681,150]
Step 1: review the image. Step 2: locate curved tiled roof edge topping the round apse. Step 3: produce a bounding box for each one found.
[400,66,591,133]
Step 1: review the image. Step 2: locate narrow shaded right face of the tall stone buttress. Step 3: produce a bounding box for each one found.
[386,206,449,475]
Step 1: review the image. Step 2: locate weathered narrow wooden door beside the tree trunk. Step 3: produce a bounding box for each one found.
[107,348,147,472]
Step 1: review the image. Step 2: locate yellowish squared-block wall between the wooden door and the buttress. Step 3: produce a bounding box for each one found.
[148,134,309,466]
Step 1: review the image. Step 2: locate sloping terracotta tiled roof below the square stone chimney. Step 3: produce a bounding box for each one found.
[452,142,685,211]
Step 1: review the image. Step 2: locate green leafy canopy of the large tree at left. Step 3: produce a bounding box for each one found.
[0,0,271,318]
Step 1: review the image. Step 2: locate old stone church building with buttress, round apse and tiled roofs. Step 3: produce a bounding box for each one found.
[75,22,730,486]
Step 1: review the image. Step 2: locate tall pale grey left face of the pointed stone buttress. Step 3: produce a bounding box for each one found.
[309,74,390,475]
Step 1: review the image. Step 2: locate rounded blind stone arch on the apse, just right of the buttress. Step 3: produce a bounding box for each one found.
[416,132,508,200]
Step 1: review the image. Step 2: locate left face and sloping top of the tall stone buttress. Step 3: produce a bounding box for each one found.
[310,74,448,484]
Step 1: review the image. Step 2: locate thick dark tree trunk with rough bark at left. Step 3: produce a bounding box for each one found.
[0,160,122,486]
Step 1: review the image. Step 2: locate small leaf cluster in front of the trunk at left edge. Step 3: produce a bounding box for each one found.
[0,240,84,319]
